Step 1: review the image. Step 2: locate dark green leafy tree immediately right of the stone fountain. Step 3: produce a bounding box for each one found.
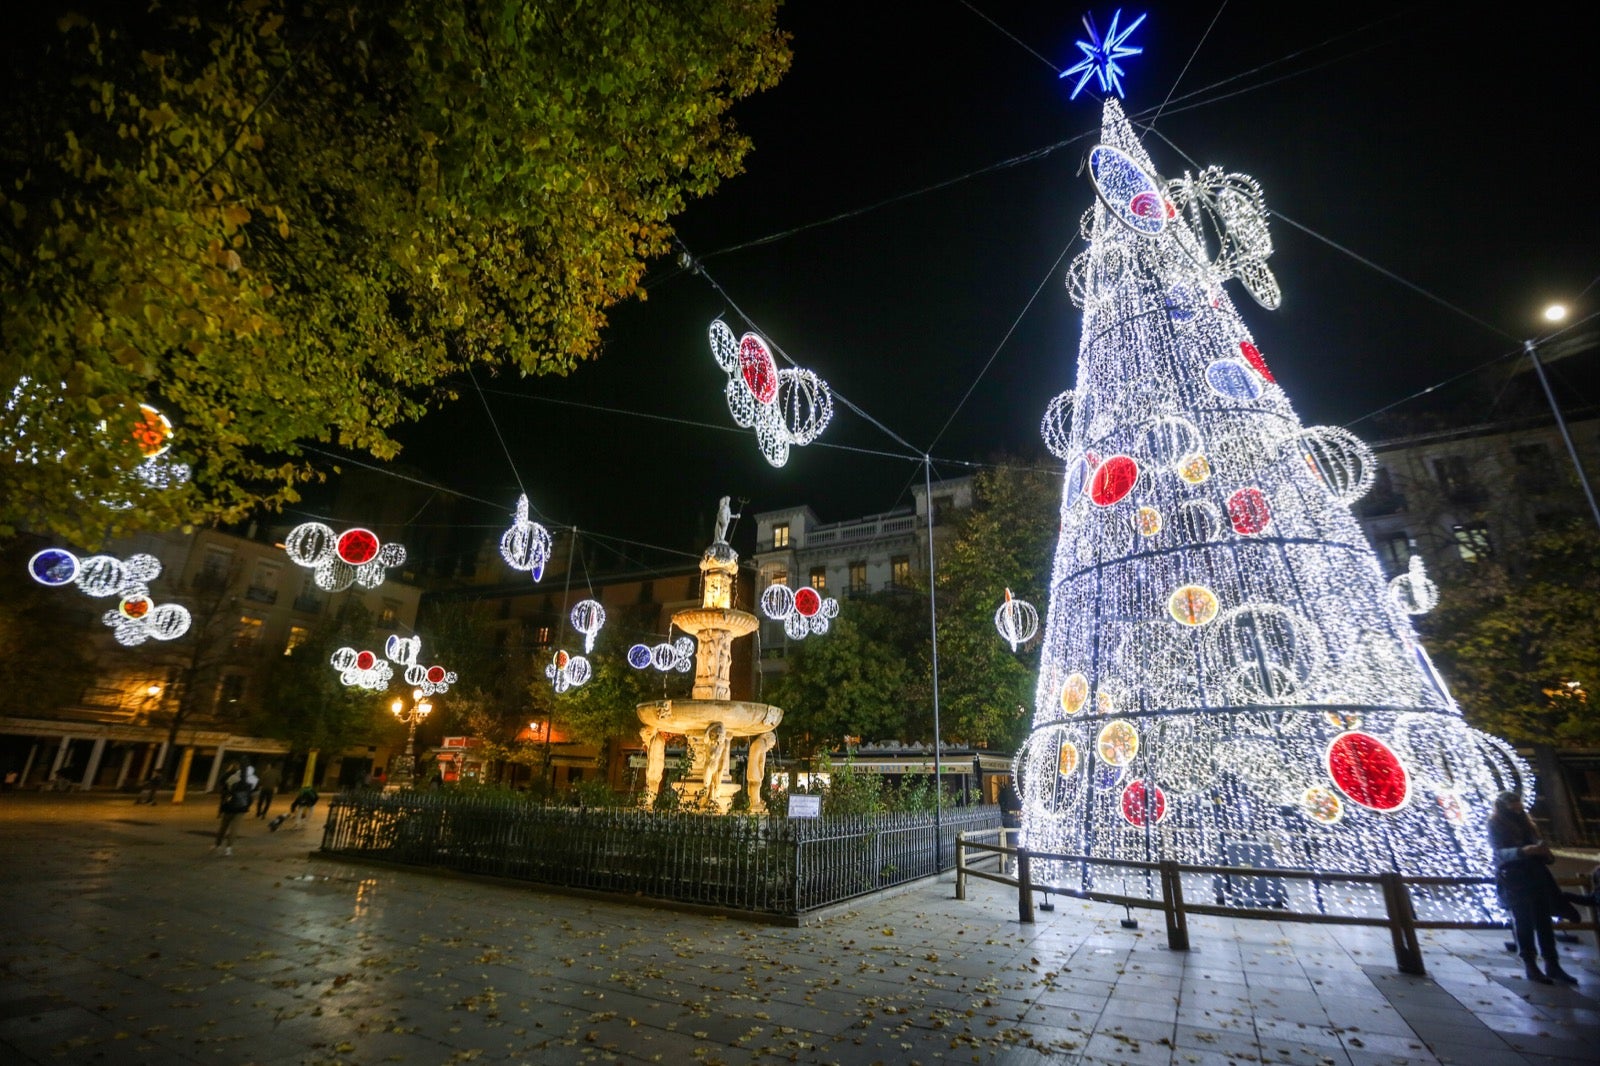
[766,595,933,757]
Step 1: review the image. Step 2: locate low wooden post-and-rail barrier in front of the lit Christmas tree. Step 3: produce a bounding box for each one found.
[955,829,1600,975]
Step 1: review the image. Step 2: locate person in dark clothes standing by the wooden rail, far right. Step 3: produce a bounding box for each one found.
[1488,792,1578,984]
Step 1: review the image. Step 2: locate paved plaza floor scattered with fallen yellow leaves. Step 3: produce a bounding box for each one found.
[0,794,1600,1066]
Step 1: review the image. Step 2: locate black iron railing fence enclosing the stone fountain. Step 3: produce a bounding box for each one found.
[322,792,1000,917]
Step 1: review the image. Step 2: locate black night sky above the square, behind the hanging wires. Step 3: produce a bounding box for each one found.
[387,0,1600,573]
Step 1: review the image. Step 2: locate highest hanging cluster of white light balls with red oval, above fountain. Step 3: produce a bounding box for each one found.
[710,319,834,466]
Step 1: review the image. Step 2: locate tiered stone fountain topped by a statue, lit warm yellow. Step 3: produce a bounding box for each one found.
[638,496,784,812]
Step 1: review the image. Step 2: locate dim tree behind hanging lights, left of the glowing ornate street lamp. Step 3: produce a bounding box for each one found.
[251,602,384,752]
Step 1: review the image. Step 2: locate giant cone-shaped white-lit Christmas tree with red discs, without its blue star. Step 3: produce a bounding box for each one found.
[1018,101,1528,916]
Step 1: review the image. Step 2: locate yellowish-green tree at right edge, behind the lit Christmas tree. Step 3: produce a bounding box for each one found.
[1419,523,1600,746]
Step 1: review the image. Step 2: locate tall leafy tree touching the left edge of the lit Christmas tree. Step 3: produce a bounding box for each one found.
[936,464,1061,749]
